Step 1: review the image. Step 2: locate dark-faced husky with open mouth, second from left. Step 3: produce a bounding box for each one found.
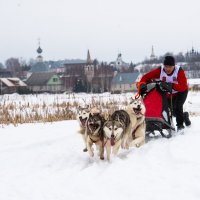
[85,109,105,160]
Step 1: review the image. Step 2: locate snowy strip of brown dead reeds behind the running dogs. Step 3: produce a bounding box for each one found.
[0,94,131,126]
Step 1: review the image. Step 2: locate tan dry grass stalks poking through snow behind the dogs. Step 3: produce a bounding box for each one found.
[0,95,127,126]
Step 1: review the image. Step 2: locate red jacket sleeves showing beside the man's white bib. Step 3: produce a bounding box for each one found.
[140,67,188,92]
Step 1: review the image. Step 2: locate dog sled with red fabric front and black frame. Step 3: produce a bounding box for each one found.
[135,81,175,138]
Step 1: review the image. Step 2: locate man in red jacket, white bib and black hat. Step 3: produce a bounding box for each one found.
[140,56,191,130]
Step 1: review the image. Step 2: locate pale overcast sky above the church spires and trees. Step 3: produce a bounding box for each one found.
[0,0,200,63]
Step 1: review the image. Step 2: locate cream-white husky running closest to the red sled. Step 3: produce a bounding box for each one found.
[122,97,146,148]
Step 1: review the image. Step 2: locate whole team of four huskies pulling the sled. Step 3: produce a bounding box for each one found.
[77,98,145,160]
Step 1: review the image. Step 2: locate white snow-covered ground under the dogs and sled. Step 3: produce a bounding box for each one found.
[0,93,200,200]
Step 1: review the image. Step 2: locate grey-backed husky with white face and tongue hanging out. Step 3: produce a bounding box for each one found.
[103,110,130,160]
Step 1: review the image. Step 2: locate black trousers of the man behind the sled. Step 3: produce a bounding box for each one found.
[169,90,188,126]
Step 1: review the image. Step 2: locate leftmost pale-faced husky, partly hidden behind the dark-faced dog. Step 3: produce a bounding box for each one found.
[76,106,90,152]
